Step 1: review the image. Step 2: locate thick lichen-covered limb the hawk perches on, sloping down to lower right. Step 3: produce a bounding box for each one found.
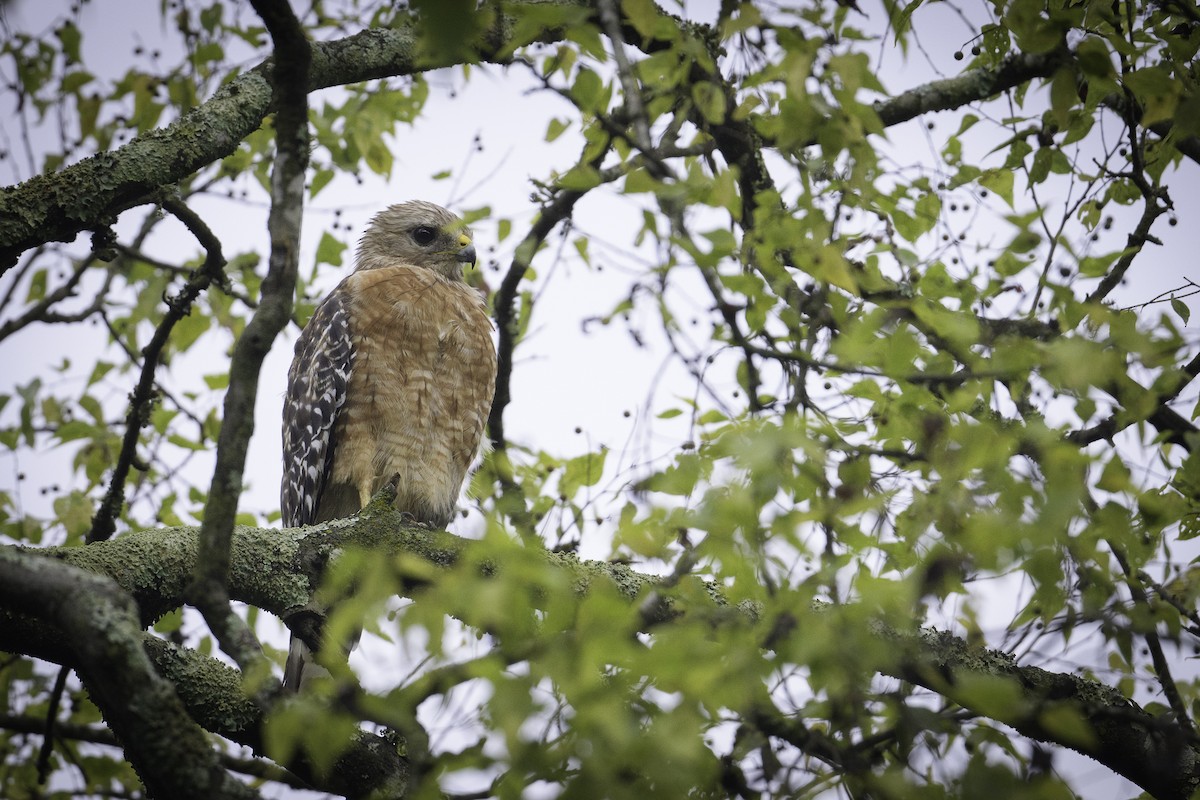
[0,511,1200,800]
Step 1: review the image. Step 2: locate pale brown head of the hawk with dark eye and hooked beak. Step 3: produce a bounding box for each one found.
[355,200,475,281]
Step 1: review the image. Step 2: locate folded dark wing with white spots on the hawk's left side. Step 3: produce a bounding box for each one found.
[280,282,354,528]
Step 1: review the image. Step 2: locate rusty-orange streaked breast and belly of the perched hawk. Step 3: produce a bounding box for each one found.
[331,266,496,525]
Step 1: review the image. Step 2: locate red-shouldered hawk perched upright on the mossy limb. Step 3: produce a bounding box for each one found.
[281,201,496,691]
